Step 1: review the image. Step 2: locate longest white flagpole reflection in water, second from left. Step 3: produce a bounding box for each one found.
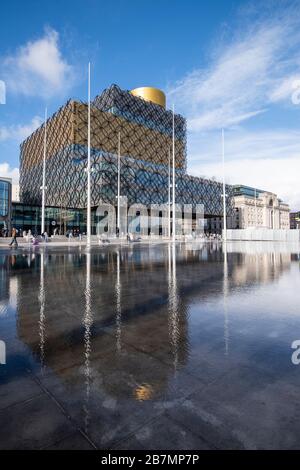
[83,252,93,432]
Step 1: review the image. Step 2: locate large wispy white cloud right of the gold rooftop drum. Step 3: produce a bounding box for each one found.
[168,13,300,132]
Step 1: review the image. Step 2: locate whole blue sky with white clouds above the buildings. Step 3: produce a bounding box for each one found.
[0,0,300,209]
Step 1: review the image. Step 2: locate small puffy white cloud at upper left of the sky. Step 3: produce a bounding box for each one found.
[1,29,73,98]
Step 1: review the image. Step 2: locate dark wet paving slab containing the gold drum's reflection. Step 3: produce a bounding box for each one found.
[32,346,202,448]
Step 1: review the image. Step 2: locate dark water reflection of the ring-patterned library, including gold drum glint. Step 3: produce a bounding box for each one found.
[18,248,188,400]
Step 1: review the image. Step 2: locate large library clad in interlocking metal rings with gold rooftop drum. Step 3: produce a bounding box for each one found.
[17,85,234,233]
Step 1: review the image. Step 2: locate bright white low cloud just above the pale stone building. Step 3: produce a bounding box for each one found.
[189,129,300,210]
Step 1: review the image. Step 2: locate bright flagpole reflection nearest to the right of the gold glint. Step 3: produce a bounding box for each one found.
[168,243,179,372]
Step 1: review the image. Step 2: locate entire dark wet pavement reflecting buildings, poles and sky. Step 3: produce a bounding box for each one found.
[0,243,300,449]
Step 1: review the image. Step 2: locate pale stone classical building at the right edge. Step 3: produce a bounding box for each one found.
[232,185,290,229]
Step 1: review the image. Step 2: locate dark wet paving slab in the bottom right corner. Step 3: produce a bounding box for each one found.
[167,367,300,449]
